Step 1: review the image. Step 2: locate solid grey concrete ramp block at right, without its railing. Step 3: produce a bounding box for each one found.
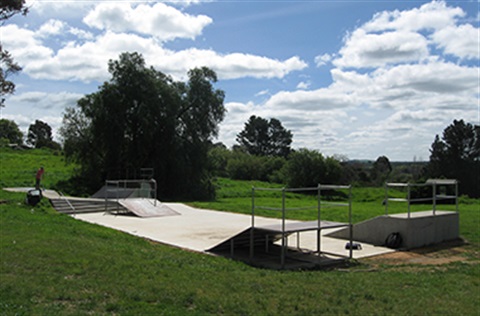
[328,211,460,249]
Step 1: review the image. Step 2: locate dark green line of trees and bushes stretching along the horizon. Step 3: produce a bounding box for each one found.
[0,53,480,200]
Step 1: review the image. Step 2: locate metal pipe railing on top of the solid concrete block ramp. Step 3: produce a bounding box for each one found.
[384,179,458,218]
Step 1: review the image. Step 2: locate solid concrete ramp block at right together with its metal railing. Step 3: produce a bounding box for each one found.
[329,179,460,250]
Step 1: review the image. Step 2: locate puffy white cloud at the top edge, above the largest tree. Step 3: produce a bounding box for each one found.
[83,2,212,41]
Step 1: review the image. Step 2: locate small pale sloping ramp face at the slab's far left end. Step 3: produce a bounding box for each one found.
[118,198,180,217]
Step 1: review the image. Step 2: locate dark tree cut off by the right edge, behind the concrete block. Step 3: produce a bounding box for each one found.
[428,120,480,197]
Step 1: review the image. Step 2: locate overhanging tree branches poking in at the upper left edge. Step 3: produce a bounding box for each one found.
[0,0,28,107]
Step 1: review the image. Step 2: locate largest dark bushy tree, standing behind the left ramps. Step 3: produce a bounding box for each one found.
[61,53,225,198]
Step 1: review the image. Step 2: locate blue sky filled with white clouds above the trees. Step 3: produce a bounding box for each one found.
[0,0,480,161]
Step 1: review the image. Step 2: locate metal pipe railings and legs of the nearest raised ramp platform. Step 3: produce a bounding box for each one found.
[249,184,353,269]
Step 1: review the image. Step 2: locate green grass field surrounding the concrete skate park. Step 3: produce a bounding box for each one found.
[0,149,480,315]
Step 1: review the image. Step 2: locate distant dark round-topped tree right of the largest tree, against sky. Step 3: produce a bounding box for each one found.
[237,115,292,157]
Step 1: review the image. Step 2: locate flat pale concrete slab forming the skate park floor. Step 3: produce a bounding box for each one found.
[74,203,393,258]
